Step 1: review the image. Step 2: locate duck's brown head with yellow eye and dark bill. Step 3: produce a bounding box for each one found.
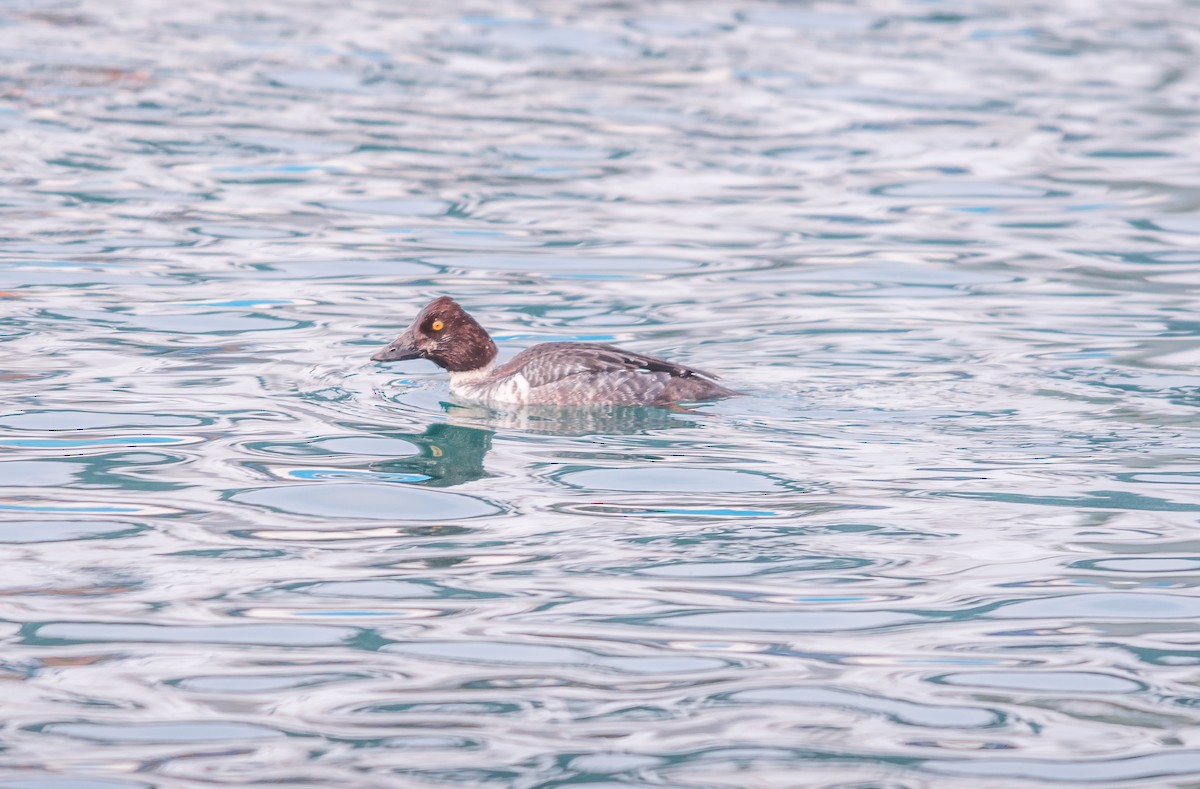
[371,296,496,373]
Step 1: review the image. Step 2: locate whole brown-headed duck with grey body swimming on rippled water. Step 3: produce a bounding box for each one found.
[371,296,743,405]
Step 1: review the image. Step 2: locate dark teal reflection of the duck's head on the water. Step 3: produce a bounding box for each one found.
[371,422,494,488]
